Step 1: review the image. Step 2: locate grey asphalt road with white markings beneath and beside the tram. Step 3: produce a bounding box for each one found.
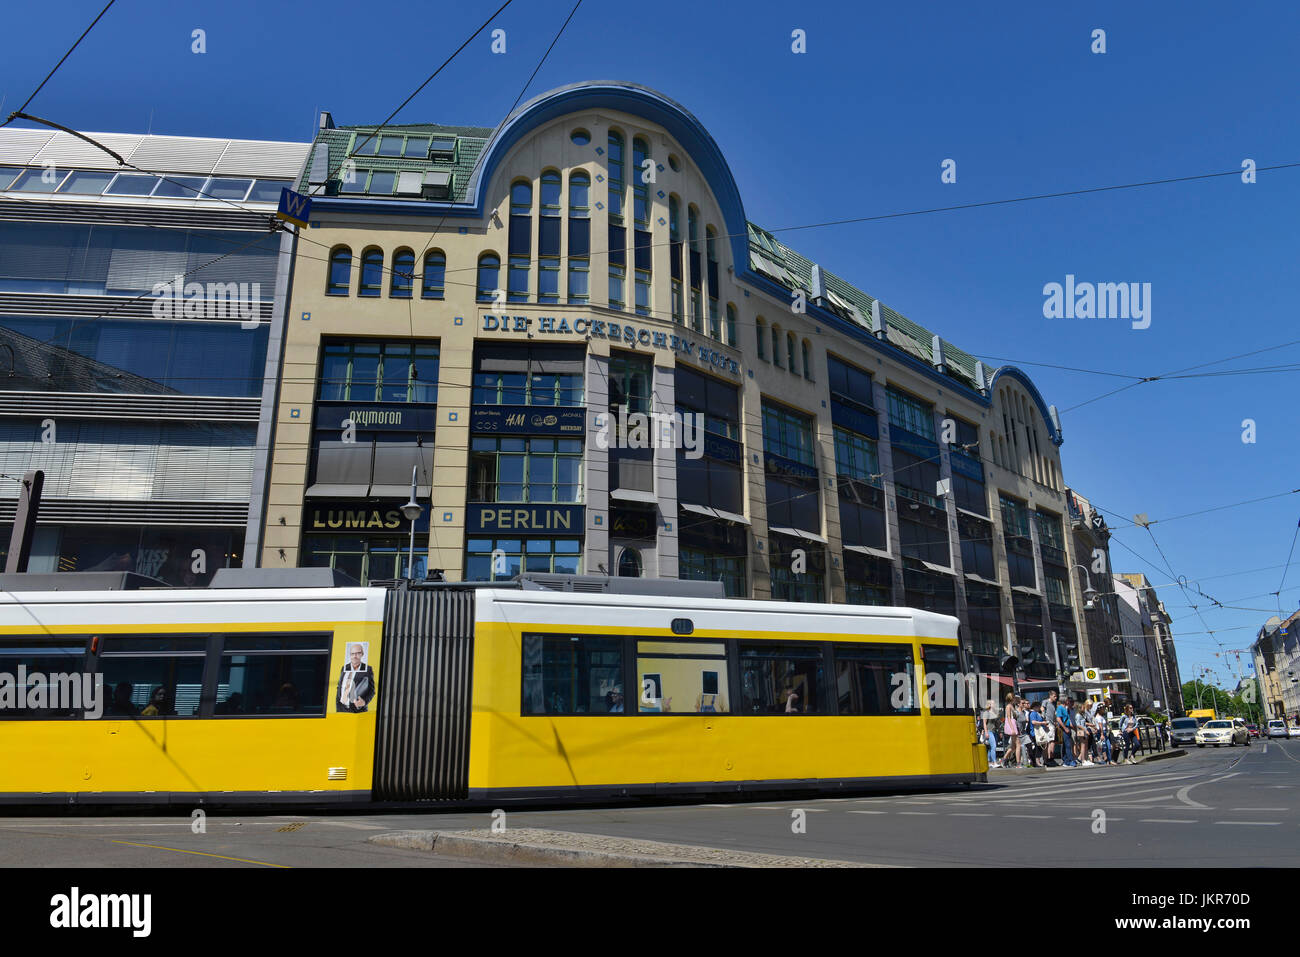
[0,740,1300,867]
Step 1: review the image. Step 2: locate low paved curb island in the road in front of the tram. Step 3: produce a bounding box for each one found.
[367,828,887,869]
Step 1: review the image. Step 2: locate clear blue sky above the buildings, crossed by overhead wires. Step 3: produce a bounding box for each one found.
[0,0,1300,680]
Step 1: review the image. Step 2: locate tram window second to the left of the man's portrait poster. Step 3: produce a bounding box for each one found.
[99,638,205,718]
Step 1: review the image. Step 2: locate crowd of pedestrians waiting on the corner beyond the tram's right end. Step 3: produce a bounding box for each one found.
[979,690,1141,768]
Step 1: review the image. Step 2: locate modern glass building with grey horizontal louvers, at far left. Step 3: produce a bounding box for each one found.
[0,129,309,584]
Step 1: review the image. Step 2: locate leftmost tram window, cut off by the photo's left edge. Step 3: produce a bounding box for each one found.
[0,638,89,719]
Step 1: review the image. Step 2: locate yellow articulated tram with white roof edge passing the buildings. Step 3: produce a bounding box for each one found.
[0,570,987,806]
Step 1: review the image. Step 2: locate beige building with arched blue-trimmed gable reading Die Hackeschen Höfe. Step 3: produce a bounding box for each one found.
[260,83,1082,677]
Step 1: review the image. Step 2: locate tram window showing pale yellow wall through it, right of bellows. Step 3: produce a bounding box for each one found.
[637,641,731,714]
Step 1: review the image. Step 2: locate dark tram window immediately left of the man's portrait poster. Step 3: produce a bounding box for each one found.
[213,635,330,716]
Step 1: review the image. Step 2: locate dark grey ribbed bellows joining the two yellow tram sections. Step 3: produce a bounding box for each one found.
[372,588,475,801]
